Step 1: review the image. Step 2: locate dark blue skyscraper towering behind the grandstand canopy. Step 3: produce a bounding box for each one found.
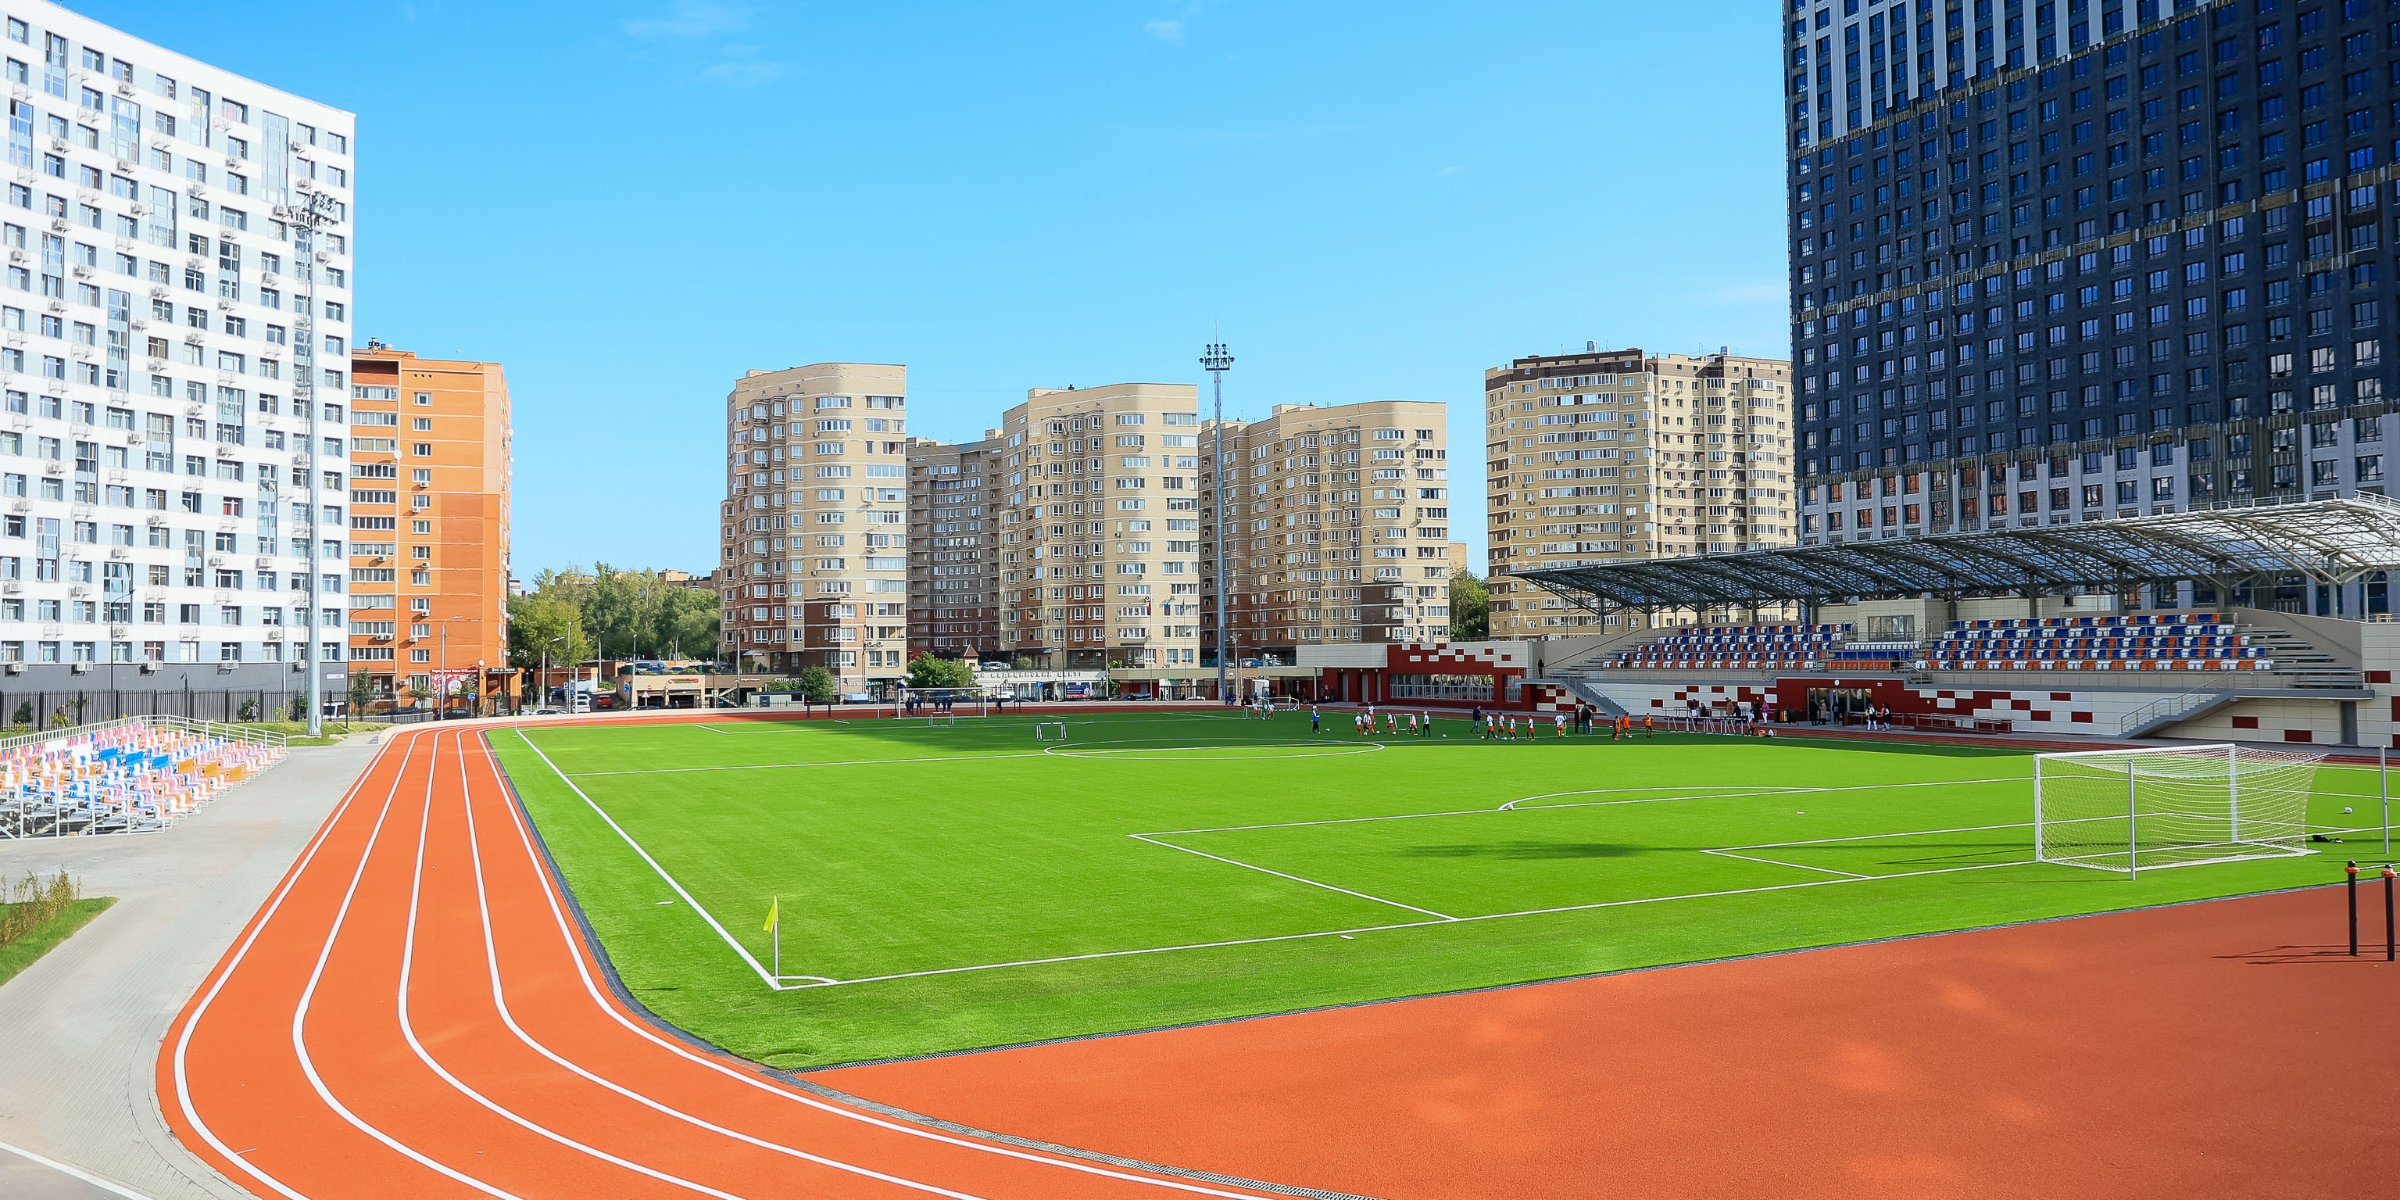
[1786,0,2400,559]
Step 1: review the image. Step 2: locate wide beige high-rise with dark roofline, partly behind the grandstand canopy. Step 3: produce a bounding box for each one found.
[1483,348,1798,638]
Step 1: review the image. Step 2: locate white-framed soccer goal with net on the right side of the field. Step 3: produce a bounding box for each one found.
[2033,744,2321,876]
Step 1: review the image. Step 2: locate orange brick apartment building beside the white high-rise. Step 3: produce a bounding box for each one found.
[350,341,511,708]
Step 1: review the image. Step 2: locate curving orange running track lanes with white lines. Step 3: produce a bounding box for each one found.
[158,730,1315,1200]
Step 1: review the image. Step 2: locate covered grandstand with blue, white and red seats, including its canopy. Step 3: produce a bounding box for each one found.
[1524,497,2400,746]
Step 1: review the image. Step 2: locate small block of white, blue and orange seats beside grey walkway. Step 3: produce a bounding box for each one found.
[0,720,283,838]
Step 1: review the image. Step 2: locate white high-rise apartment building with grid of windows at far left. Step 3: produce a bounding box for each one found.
[0,0,355,696]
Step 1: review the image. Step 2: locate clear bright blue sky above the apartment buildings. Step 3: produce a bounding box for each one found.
[72,0,1790,578]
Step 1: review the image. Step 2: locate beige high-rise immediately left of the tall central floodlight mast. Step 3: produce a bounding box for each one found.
[998,384,1202,670]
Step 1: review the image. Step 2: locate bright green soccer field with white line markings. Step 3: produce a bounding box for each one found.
[490,710,2381,1068]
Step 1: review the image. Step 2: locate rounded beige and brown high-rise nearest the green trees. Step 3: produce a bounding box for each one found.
[718,362,910,691]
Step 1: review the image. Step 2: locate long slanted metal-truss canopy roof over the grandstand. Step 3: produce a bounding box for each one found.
[1517,497,2400,610]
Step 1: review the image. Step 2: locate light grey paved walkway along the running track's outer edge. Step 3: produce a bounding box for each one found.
[0,737,374,1200]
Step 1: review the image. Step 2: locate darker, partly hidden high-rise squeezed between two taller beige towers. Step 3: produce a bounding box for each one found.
[907,430,1008,658]
